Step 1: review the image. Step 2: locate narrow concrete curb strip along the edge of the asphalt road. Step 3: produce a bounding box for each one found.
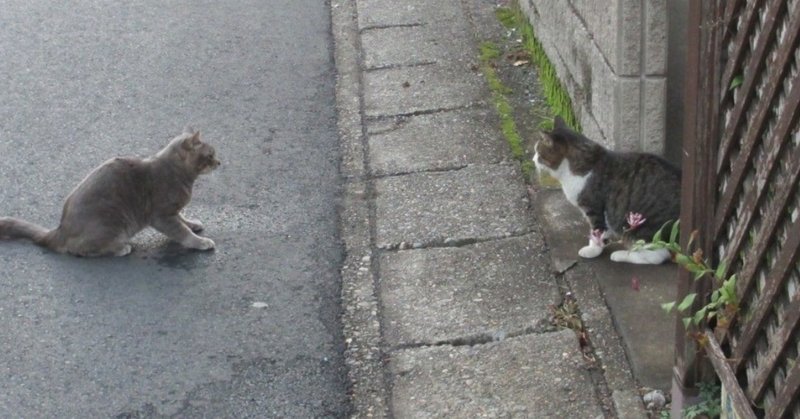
[331,0,388,418]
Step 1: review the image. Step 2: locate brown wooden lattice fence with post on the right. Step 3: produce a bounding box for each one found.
[675,0,800,418]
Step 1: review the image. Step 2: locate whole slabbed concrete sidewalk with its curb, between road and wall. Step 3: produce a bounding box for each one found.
[331,0,672,418]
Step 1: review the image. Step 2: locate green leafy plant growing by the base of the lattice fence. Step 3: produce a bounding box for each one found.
[634,221,739,328]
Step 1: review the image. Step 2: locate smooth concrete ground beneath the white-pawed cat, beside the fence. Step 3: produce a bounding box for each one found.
[534,189,677,392]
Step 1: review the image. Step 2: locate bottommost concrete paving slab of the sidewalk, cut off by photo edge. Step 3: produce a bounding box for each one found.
[390,330,603,418]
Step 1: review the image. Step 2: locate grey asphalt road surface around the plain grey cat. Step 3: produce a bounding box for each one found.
[0,0,348,418]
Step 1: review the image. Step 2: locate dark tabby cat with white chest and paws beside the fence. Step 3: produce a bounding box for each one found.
[533,117,681,264]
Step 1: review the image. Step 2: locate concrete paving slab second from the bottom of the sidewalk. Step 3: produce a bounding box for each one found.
[379,234,561,347]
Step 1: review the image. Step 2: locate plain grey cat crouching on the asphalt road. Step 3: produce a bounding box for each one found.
[0,128,220,256]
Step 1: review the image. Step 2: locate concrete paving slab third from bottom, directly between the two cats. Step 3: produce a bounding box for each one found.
[374,164,531,248]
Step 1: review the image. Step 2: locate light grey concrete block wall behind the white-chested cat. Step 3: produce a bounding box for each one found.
[519,0,669,154]
